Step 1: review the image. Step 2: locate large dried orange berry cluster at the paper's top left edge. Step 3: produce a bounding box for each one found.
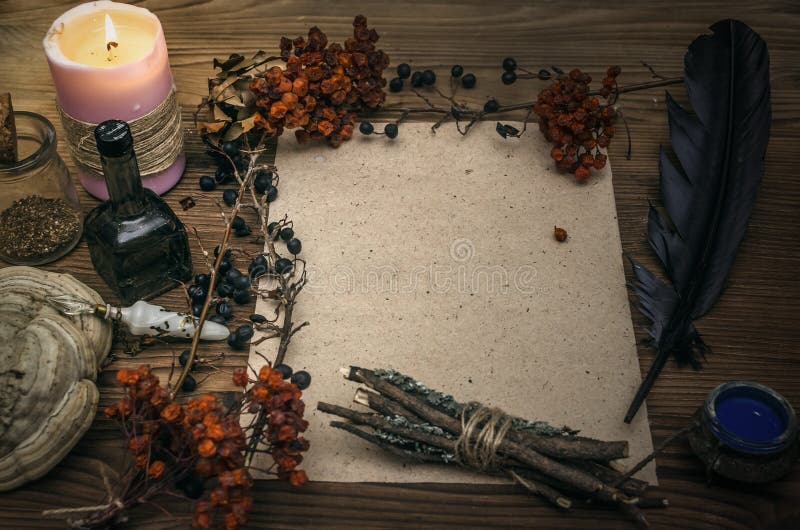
[250,15,389,147]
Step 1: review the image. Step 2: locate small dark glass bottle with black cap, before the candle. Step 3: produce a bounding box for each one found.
[86,120,192,304]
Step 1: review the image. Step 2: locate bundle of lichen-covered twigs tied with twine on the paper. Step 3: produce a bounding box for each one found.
[317,366,667,526]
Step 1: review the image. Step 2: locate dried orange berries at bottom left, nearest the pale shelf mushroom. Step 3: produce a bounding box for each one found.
[105,366,268,530]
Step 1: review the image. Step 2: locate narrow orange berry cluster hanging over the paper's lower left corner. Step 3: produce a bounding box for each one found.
[233,366,309,486]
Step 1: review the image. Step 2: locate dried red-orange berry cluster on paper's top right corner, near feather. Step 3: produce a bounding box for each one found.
[533,66,620,180]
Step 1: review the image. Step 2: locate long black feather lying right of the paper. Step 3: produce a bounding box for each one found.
[625,20,771,422]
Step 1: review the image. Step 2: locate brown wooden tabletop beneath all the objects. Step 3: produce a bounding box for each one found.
[0,0,800,529]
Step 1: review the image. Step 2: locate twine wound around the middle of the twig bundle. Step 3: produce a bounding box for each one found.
[455,403,511,471]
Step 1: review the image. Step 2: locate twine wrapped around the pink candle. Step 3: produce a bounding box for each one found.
[56,90,183,176]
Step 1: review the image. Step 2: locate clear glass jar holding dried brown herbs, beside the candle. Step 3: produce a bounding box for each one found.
[0,111,83,265]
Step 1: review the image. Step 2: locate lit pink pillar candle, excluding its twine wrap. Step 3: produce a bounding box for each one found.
[44,1,186,199]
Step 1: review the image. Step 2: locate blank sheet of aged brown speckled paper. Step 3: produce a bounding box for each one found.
[251,123,655,482]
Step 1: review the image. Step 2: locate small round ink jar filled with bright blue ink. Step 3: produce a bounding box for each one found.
[689,381,798,483]
